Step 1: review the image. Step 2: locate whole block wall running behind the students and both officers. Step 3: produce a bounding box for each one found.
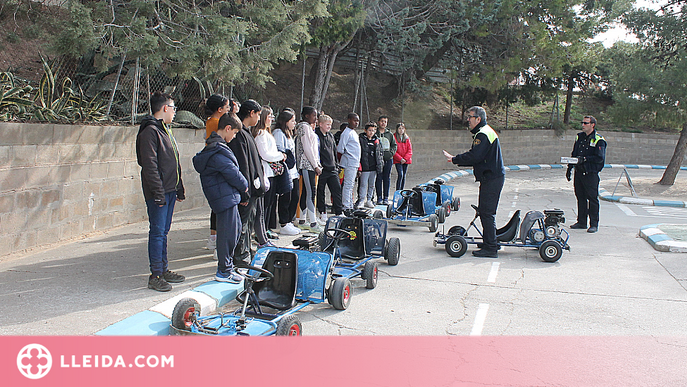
[0,123,678,256]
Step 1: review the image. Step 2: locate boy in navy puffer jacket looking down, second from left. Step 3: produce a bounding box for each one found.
[193,114,248,284]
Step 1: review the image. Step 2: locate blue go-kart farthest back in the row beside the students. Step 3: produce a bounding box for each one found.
[386,179,460,232]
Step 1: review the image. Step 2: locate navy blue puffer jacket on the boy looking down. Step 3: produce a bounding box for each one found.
[193,132,248,212]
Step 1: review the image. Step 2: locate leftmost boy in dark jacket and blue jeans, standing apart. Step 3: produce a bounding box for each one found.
[136,92,186,292]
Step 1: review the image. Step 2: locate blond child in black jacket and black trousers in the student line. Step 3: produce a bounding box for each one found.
[315,114,343,221]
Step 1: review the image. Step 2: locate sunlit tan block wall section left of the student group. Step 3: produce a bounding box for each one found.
[0,123,205,256]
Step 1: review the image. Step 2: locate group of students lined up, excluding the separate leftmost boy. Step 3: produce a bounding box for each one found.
[194,94,412,282]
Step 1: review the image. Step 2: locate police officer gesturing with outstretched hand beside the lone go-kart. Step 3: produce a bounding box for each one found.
[444,106,506,258]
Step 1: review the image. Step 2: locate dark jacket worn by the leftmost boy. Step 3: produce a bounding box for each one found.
[136,116,186,205]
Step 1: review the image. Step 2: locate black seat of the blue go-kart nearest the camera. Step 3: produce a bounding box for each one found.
[253,251,298,310]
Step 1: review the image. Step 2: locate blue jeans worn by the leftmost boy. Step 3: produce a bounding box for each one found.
[146,192,177,276]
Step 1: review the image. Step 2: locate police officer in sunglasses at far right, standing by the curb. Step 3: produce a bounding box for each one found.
[565,116,606,233]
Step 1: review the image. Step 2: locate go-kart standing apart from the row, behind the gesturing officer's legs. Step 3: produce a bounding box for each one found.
[434,205,570,262]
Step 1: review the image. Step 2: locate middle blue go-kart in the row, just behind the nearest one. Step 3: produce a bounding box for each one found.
[318,210,401,289]
